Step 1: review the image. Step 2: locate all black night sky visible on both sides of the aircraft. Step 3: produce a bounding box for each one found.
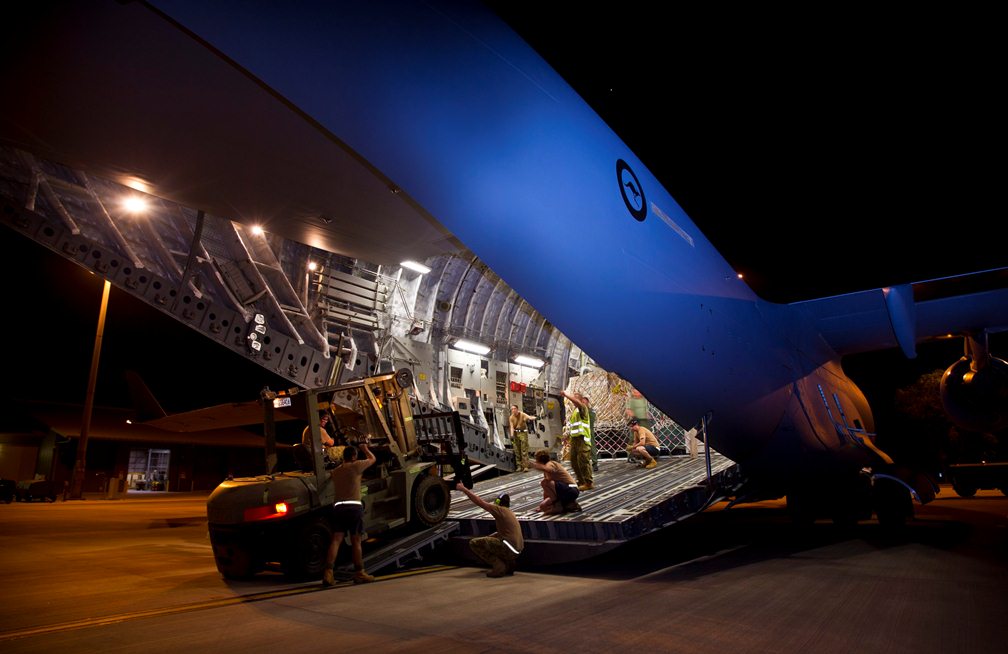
[0,2,1008,423]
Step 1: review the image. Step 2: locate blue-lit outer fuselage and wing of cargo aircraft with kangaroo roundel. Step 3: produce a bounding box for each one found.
[0,0,1008,523]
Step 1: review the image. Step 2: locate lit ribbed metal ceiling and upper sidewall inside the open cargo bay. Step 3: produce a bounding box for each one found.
[0,146,582,388]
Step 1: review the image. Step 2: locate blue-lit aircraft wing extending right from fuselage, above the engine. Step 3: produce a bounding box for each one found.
[792,268,1008,358]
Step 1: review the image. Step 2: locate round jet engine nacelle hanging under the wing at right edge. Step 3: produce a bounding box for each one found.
[941,357,1008,433]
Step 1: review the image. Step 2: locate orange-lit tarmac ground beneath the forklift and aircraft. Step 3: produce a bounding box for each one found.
[0,477,1008,654]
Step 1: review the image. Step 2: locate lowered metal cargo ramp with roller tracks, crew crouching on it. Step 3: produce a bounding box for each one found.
[447,452,739,565]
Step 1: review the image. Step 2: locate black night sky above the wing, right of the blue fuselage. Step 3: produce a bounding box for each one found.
[490,1,1008,301]
